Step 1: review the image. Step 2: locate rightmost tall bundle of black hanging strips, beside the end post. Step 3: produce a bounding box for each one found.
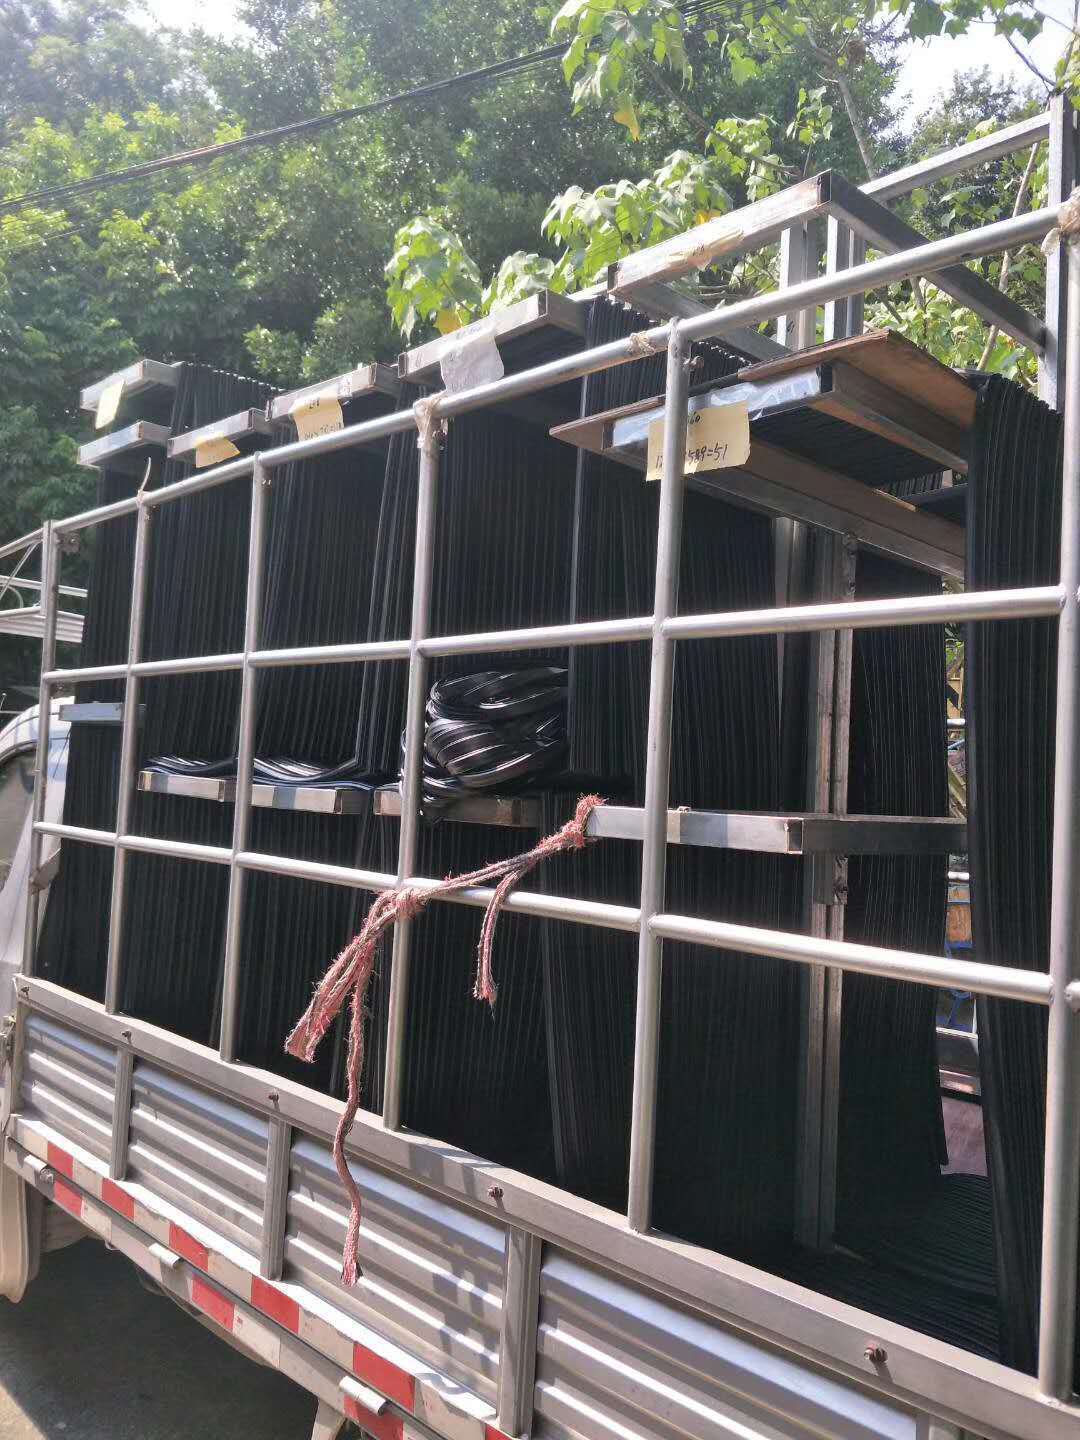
[965,379,1061,1371]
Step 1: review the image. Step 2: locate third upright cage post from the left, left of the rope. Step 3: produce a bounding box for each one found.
[220,458,269,1061]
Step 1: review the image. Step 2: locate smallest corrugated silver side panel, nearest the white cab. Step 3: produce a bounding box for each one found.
[22,1015,115,1161]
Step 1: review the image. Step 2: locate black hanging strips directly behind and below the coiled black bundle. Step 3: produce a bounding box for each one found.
[351,392,575,1176]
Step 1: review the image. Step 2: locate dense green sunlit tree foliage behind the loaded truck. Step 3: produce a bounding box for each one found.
[0,0,1080,613]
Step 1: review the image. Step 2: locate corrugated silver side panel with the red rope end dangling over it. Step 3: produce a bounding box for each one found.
[285,1136,505,1400]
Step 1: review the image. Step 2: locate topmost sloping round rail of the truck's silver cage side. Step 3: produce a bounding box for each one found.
[46,206,1057,534]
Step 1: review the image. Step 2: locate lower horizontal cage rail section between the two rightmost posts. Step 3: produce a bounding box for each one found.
[649,914,1060,1008]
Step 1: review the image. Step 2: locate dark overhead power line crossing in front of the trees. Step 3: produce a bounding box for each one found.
[0,0,753,215]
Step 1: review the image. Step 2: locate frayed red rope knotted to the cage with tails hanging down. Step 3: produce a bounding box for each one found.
[285,795,603,1284]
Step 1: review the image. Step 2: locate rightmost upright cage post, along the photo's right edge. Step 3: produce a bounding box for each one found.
[1038,236,1080,1400]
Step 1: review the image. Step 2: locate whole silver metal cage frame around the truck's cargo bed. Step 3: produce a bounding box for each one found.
[8,98,1080,1440]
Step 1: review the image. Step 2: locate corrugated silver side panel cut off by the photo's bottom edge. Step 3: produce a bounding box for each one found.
[533,1248,916,1440]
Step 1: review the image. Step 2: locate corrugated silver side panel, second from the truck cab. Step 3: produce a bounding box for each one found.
[128,1061,268,1254]
